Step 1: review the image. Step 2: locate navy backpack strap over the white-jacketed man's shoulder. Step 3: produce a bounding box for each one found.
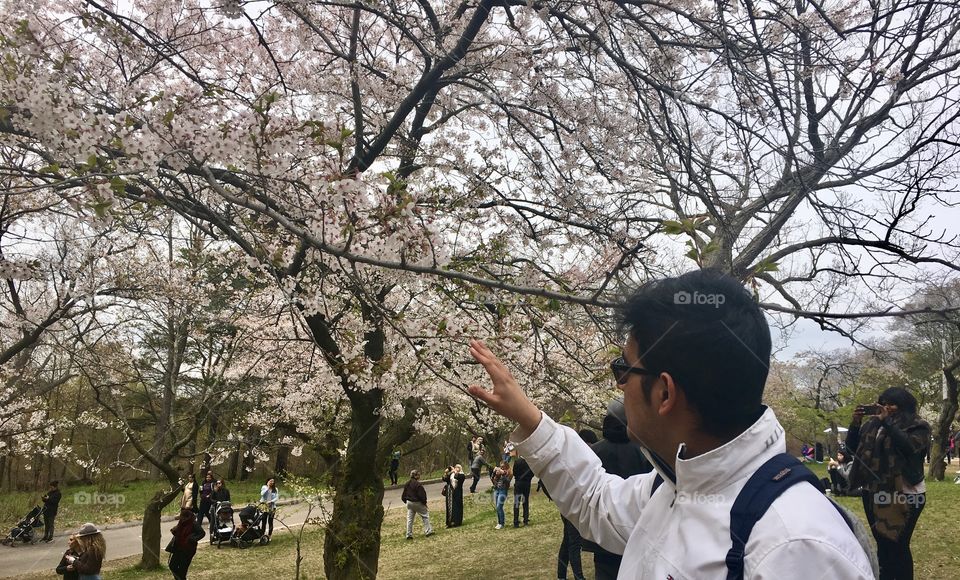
[726,453,820,580]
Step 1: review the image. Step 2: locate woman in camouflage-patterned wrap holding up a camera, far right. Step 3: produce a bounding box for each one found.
[846,387,930,580]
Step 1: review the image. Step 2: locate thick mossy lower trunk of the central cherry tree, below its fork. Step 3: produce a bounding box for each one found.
[323,389,383,580]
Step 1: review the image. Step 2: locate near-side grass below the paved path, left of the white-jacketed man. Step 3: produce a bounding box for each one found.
[24,493,593,580]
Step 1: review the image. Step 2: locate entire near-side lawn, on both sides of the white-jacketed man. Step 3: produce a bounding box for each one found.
[13,465,960,580]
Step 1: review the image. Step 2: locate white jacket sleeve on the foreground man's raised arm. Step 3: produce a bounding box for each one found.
[518,413,656,554]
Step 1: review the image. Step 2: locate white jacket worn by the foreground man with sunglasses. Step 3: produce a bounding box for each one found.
[518,409,874,580]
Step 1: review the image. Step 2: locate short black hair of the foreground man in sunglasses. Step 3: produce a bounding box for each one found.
[621,269,771,437]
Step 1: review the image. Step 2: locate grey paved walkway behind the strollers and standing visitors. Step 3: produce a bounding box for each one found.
[0,477,490,578]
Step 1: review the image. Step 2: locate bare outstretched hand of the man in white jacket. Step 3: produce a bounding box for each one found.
[467,340,540,439]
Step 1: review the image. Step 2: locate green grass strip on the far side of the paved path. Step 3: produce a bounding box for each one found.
[0,480,266,530]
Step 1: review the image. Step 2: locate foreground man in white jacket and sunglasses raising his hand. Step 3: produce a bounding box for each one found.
[470,270,874,580]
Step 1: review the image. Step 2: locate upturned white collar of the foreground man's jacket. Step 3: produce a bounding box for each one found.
[645,407,787,493]
